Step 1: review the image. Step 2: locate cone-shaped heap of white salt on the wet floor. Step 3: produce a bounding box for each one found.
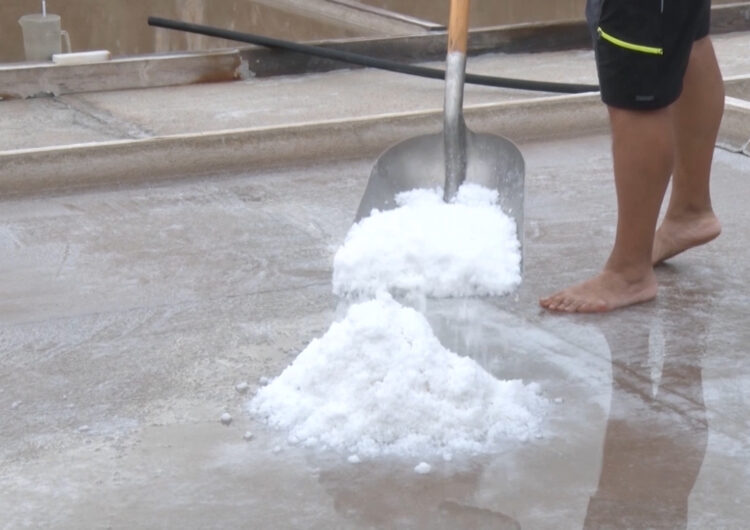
[249,293,546,457]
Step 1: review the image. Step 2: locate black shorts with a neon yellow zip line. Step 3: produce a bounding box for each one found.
[586,0,711,110]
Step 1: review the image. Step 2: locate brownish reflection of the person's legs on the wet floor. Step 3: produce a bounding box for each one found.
[584,278,711,529]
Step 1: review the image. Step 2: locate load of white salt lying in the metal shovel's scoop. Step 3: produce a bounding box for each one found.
[333,184,521,297]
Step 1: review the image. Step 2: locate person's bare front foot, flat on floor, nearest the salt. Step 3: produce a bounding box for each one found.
[539,270,657,313]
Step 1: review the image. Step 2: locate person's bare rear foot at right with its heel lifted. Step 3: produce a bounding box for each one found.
[651,211,721,265]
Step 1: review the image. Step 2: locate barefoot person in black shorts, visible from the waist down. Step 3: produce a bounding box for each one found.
[540,0,724,312]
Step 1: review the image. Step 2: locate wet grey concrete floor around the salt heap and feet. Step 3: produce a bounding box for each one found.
[0,131,750,529]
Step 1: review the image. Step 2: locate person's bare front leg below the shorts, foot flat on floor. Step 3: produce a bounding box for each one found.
[539,107,674,313]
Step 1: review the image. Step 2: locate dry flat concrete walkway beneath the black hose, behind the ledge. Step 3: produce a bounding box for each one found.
[0,33,750,151]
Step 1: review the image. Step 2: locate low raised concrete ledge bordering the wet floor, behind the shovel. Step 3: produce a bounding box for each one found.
[0,93,607,198]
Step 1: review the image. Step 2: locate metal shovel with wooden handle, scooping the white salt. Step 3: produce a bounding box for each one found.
[356,0,524,252]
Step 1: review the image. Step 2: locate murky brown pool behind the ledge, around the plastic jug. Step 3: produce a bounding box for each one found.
[0,0,364,62]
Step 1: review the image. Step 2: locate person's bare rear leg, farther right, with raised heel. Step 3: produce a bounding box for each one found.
[652,37,724,264]
